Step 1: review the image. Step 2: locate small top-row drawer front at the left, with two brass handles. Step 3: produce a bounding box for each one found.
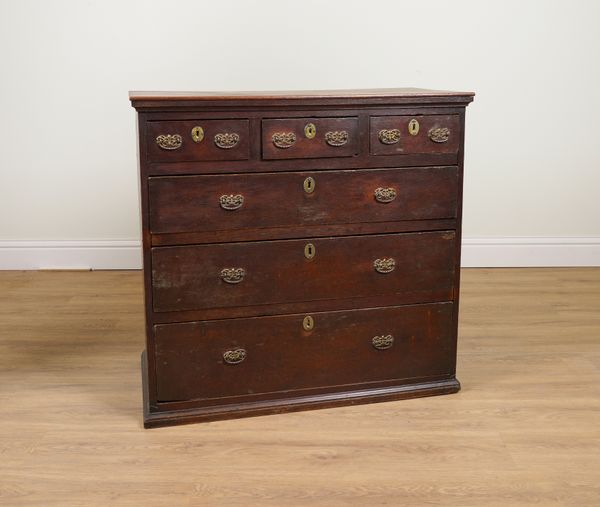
[147,120,249,162]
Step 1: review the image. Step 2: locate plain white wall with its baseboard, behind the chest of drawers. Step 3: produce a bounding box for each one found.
[0,0,600,267]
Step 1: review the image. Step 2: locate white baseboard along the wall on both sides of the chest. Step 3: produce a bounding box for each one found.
[0,237,600,270]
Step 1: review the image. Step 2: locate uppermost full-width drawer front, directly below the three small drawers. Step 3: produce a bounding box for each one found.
[149,167,458,233]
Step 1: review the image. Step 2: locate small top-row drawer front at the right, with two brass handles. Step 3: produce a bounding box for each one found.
[370,115,461,155]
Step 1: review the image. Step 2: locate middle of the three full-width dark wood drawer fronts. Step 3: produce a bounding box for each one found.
[152,231,455,312]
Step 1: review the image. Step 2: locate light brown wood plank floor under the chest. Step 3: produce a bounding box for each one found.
[0,269,600,507]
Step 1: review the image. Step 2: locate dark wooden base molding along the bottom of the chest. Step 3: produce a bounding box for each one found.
[142,351,460,428]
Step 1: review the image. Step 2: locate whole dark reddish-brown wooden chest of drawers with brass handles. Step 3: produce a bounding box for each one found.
[130,89,473,427]
